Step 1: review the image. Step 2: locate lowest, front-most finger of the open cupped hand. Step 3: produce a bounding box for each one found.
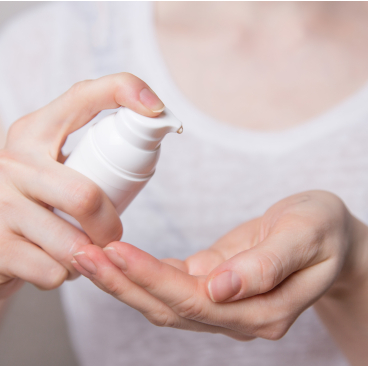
[72,245,254,341]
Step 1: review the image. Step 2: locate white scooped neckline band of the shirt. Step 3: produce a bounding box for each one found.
[126,2,368,154]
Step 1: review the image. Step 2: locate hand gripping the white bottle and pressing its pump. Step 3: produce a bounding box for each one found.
[0,73,164,301]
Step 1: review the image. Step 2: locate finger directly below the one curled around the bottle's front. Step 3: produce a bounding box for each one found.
[3,195,91,278]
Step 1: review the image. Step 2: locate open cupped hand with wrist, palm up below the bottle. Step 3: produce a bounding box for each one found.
[72,191,368,365]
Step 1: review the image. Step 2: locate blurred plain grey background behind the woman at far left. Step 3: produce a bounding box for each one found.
[0,1,77,366]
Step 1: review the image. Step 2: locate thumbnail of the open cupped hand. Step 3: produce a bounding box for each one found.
[208,271,241,302]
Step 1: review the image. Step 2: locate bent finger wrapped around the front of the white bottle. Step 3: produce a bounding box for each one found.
[10,158,122,246]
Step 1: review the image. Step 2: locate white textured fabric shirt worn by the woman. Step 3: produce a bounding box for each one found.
[0,3,368,366]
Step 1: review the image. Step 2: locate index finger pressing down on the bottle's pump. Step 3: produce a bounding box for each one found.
[7,73,164,159]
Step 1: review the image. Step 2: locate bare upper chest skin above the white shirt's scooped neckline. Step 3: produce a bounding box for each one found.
[156,2,368,131]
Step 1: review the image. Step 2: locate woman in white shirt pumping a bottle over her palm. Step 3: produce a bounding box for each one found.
[0,3,368,365]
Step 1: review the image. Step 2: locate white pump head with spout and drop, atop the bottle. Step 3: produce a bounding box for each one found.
[115,107,183,150]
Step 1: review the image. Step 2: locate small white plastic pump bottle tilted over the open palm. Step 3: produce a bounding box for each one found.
[54,107,183,230]
